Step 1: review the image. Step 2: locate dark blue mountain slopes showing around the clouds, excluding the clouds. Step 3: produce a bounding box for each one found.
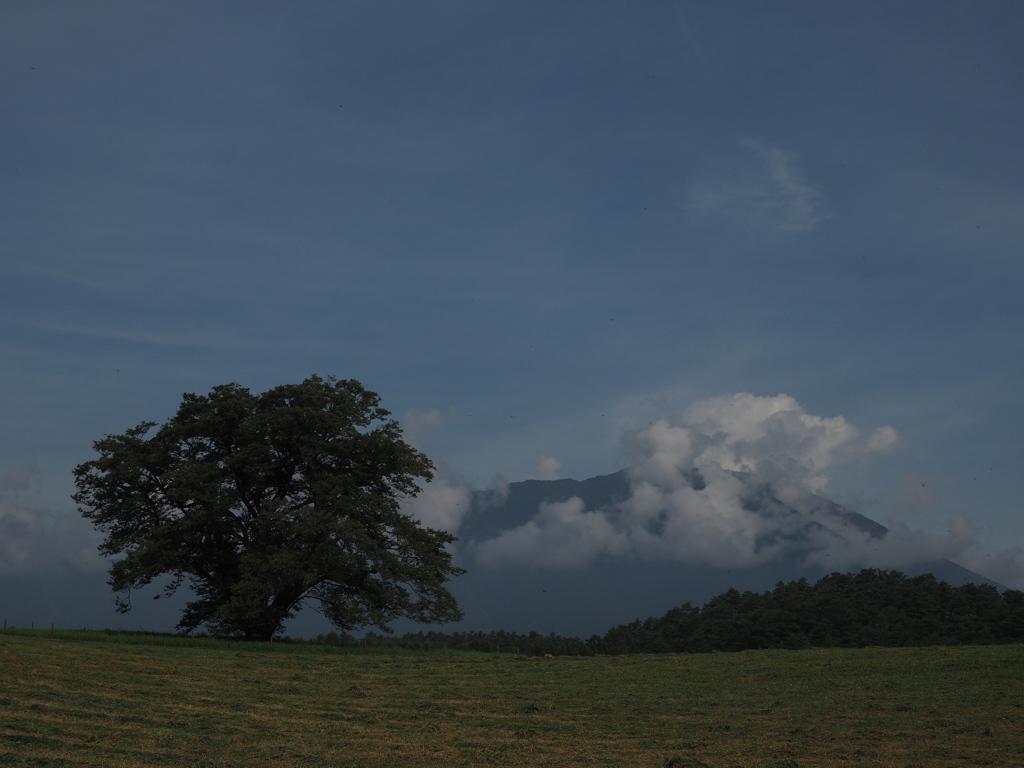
[434,470,993,636]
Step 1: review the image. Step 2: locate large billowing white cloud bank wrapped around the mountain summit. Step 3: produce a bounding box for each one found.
[475,392,1021,578]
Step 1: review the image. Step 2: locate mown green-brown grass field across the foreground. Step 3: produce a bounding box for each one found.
[0,631,1024,768]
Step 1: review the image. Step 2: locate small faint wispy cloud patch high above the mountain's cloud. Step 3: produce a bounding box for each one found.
[686,139,827,232]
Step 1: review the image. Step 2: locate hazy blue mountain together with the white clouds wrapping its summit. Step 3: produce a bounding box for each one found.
[397,392,999,635]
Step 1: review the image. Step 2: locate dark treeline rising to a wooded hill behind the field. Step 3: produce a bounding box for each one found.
[312,568,1024,655]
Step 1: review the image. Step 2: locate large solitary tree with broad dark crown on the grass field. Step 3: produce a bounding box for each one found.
[73,376,465,640]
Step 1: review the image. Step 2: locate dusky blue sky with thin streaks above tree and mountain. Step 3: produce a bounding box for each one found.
[0,0,1024,630]
